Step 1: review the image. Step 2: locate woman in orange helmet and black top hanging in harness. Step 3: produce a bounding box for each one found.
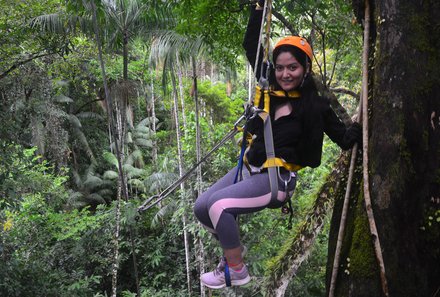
[194,1,361,289]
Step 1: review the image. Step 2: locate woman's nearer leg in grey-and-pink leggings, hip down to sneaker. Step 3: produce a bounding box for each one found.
[201,173,295,289]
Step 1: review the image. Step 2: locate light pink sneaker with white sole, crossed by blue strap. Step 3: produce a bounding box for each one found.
[200,260,251,289]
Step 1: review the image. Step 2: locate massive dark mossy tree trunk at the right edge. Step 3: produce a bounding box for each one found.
[327,0,440,297]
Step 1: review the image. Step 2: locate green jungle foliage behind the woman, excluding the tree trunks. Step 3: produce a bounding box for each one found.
[0,0,361,297]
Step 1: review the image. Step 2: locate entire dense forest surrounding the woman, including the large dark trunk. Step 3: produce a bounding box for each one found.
[0,0,440,297]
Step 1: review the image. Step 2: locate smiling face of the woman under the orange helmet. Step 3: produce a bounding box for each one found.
[275,52,305,92]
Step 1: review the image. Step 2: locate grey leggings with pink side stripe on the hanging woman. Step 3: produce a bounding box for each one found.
[194,168,296,249]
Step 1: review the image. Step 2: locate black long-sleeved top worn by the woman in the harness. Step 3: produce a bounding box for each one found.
[243,4,355,167]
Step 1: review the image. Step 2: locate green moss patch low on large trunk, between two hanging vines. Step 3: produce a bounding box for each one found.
[347,194,378,279]
